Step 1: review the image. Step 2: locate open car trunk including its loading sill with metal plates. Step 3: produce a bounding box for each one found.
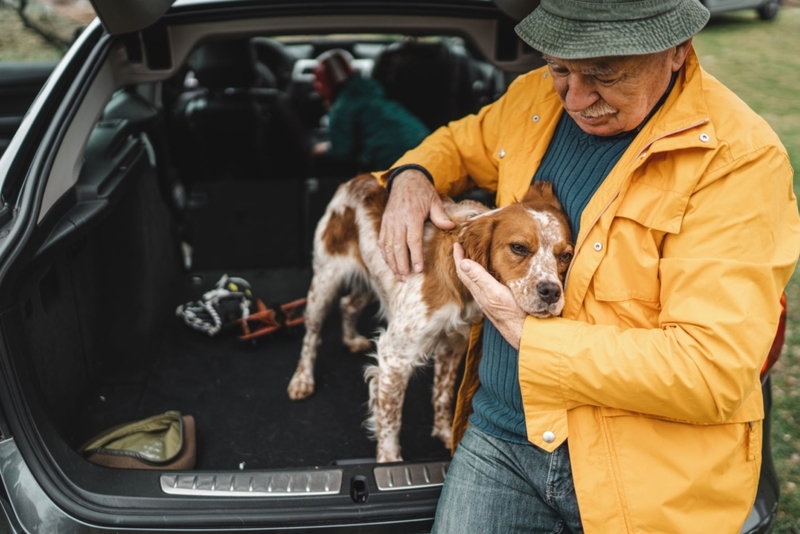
[2,90,456,530]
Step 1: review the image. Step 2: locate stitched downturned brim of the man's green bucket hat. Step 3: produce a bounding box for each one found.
[515,0,709,59]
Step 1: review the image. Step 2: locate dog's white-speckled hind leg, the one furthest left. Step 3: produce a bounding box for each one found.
[287,270,340,400]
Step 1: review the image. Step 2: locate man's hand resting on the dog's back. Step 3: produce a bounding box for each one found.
[378,169,455,282]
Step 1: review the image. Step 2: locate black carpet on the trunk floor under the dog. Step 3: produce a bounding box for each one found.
[87,270,456,470]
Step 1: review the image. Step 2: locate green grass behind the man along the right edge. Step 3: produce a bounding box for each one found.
[694,8,800,534]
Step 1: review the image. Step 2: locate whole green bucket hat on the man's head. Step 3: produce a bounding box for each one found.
[515,0,710,59]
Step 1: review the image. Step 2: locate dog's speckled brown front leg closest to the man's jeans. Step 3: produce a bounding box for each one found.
[431,333,467,449]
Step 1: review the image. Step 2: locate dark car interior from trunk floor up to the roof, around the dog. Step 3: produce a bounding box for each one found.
[4,10,540,510]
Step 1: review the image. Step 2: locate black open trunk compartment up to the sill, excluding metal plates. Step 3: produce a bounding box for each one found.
[12,86,460,469]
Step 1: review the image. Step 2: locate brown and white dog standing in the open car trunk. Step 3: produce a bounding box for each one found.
[288,175,573,462]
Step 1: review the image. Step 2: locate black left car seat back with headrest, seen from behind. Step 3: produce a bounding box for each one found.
[173,39,310,184]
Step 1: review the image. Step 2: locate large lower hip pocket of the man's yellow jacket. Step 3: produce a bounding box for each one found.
[602,413,761,532]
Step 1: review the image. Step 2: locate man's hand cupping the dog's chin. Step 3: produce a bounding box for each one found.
[453,243,528,350]
